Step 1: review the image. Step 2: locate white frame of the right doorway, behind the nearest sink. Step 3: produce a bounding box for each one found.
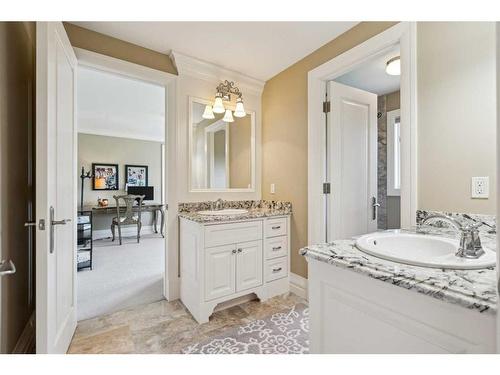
[307,22,417,244]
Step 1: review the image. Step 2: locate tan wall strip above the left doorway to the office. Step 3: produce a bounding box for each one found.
[64,22,177,74]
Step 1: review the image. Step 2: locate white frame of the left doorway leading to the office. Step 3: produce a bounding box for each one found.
[73,47,179,300]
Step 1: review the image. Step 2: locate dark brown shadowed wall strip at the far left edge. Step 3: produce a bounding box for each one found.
[0,22,35,353]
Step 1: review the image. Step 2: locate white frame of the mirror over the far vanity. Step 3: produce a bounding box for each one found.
[188,96,257,193]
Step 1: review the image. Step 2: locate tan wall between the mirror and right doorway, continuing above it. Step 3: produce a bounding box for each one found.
[262,22,395,276]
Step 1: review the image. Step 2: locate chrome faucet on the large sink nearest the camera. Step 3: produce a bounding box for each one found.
[420,214,484,259]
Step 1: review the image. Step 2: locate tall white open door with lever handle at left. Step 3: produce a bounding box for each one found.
[36,22,77,353]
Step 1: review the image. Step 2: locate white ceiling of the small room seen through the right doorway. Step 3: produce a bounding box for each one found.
[335,45,400,95]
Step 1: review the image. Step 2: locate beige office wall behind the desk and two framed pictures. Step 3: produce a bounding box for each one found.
[78,134,162,230]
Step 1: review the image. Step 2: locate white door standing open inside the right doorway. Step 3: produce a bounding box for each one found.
[327,82,377,241]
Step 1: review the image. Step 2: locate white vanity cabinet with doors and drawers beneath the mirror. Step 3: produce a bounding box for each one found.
[180,216,290,323]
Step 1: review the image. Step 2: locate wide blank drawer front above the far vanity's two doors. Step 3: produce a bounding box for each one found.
[205,220,262,247]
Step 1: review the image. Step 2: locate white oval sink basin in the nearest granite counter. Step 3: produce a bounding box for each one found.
[356,232,496,270]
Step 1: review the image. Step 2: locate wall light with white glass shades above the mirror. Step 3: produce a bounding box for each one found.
[202,80,246,122]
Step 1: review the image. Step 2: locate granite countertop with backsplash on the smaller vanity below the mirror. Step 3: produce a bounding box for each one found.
[179,201,292,224]
